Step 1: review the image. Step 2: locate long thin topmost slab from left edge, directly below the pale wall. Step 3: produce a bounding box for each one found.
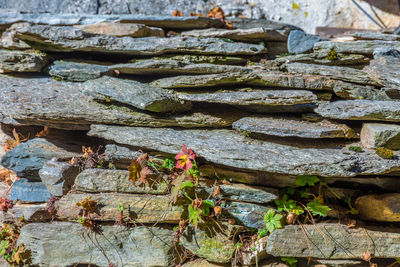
[0,12,225,30]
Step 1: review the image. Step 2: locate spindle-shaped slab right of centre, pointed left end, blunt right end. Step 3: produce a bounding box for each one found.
[178,89,318,113]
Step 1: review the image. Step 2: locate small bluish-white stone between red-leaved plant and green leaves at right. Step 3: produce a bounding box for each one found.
[221,201,270,229]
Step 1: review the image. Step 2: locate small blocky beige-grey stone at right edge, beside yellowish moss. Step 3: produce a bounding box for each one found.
[361,123,400,149]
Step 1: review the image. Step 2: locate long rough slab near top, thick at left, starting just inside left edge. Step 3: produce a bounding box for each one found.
[16,25,267,56]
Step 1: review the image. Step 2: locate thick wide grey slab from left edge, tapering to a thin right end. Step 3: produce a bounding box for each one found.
[0,75,240,130]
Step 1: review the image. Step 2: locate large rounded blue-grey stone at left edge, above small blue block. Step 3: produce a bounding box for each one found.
[1,138,79,181]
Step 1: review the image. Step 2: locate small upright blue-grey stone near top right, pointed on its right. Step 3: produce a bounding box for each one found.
[287,30,326,54]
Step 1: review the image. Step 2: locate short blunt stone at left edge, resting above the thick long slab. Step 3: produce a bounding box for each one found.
[0,50,47,72]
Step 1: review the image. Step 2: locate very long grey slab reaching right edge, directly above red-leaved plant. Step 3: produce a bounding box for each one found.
[88,125,400,177]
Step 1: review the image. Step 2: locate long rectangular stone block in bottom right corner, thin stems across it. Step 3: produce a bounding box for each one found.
[267,223,400,259]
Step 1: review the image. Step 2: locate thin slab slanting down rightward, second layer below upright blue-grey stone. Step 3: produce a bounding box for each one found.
[285,63,379,85]
